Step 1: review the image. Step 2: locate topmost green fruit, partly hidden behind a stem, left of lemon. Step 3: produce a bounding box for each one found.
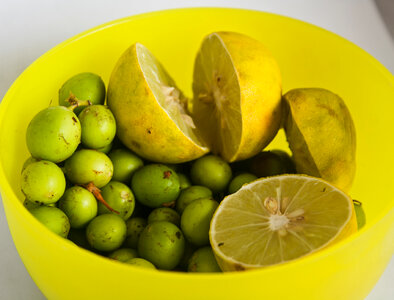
[59,72,105,113]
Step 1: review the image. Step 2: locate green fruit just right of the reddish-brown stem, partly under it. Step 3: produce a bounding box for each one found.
[98,181,135,221]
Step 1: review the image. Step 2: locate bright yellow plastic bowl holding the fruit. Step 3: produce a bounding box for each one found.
[0,8,394,300]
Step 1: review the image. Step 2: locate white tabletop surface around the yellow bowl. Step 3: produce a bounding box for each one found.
[0,0,394,300]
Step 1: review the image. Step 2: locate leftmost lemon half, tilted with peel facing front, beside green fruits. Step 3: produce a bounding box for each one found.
[107,43,209,163]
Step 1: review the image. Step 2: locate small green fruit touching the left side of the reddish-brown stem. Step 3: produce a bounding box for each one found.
[59,186,97,228]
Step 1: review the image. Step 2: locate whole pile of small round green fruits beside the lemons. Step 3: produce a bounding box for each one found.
[21,73,295,272]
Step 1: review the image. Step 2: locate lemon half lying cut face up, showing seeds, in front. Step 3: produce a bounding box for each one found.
[209,175,357,271]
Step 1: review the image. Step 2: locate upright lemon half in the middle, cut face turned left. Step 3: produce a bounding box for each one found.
[192,32,282,162]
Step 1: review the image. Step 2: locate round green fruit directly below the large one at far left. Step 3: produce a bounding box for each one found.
[21,160,66,204]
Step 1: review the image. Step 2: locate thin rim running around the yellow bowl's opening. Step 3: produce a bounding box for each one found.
[0,7,394,280]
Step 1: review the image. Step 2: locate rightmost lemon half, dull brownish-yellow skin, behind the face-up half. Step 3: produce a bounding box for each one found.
[283,88,356,192]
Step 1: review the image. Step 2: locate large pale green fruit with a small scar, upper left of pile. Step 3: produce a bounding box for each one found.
[26,106,81,163]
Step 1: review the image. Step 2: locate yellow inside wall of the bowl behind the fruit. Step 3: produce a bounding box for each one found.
[0,9,394,286]
